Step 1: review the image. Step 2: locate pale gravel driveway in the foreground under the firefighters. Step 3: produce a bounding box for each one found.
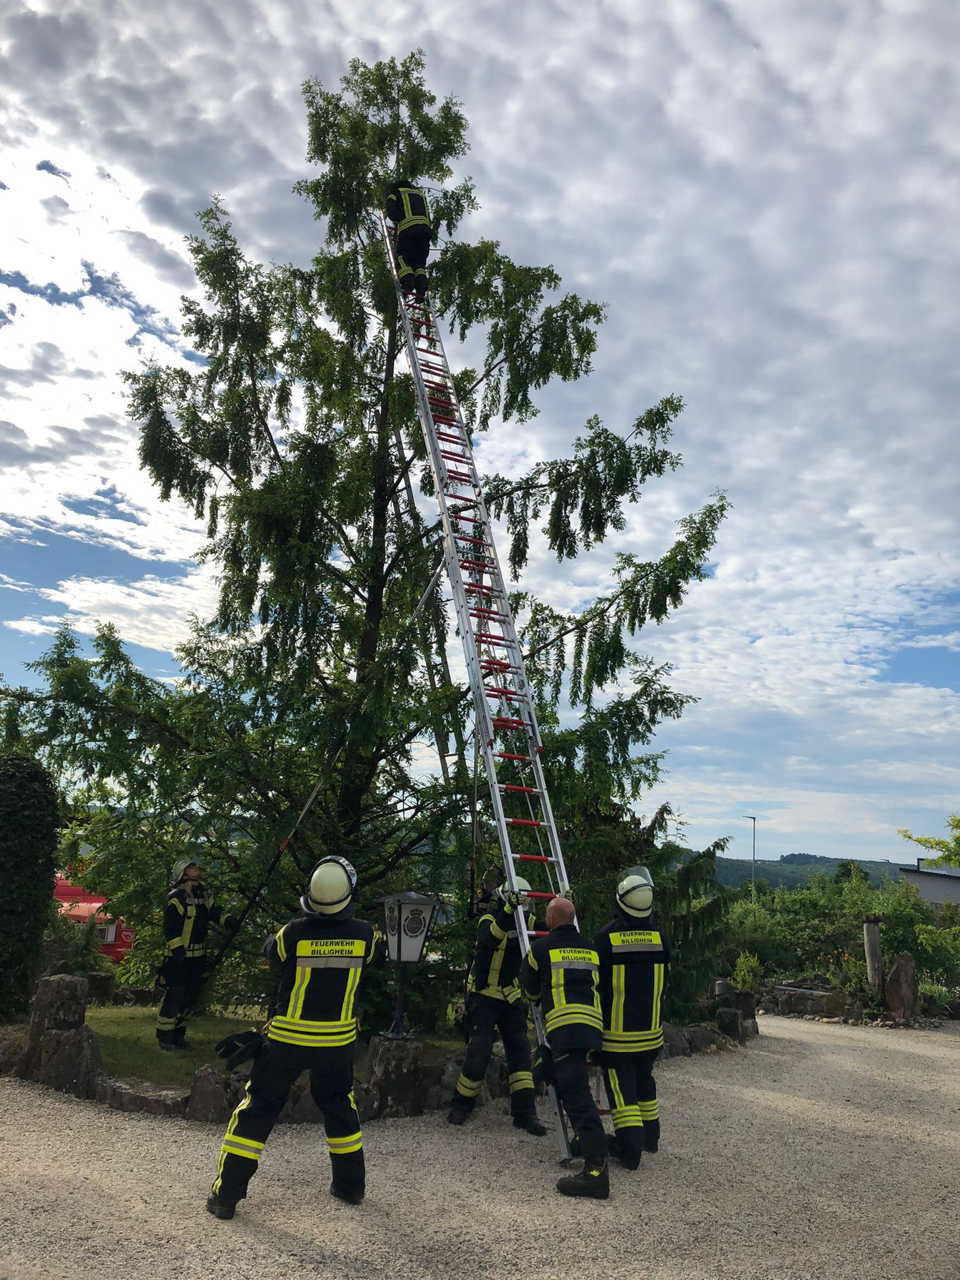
[0,1018,960,1280]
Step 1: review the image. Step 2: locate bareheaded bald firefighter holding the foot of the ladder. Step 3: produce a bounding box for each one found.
[520,897,611,1199]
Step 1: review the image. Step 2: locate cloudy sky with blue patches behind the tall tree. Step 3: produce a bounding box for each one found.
[0,0,960,861]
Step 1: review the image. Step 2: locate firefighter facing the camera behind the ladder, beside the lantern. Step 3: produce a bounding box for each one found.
[447,877,547,1138]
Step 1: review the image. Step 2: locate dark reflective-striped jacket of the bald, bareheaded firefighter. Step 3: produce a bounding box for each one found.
[520,924,603,1053]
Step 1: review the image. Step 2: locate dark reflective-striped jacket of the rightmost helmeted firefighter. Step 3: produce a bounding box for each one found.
[594,911,669,1053]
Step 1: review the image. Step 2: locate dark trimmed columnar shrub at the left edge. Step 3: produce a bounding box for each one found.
[0,751,58,1021]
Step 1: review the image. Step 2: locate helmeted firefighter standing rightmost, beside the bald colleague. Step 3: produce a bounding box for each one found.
[594,867,669,1169]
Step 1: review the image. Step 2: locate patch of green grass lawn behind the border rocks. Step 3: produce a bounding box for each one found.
[87,1005,463,1093]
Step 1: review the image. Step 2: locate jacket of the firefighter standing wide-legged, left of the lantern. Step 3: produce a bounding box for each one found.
[266,902,374,1048]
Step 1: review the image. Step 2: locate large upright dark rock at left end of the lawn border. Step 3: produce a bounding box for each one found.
[14,974,104,1098]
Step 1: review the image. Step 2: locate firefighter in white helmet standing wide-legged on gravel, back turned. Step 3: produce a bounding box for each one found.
[206,858,374,1219]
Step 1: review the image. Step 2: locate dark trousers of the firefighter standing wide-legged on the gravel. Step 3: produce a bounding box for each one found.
[212,1039,365,1201]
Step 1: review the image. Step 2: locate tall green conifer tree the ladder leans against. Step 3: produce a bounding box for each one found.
[6,52,727,996]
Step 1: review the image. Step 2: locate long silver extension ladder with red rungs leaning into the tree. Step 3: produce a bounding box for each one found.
[380,214,570,1157]
